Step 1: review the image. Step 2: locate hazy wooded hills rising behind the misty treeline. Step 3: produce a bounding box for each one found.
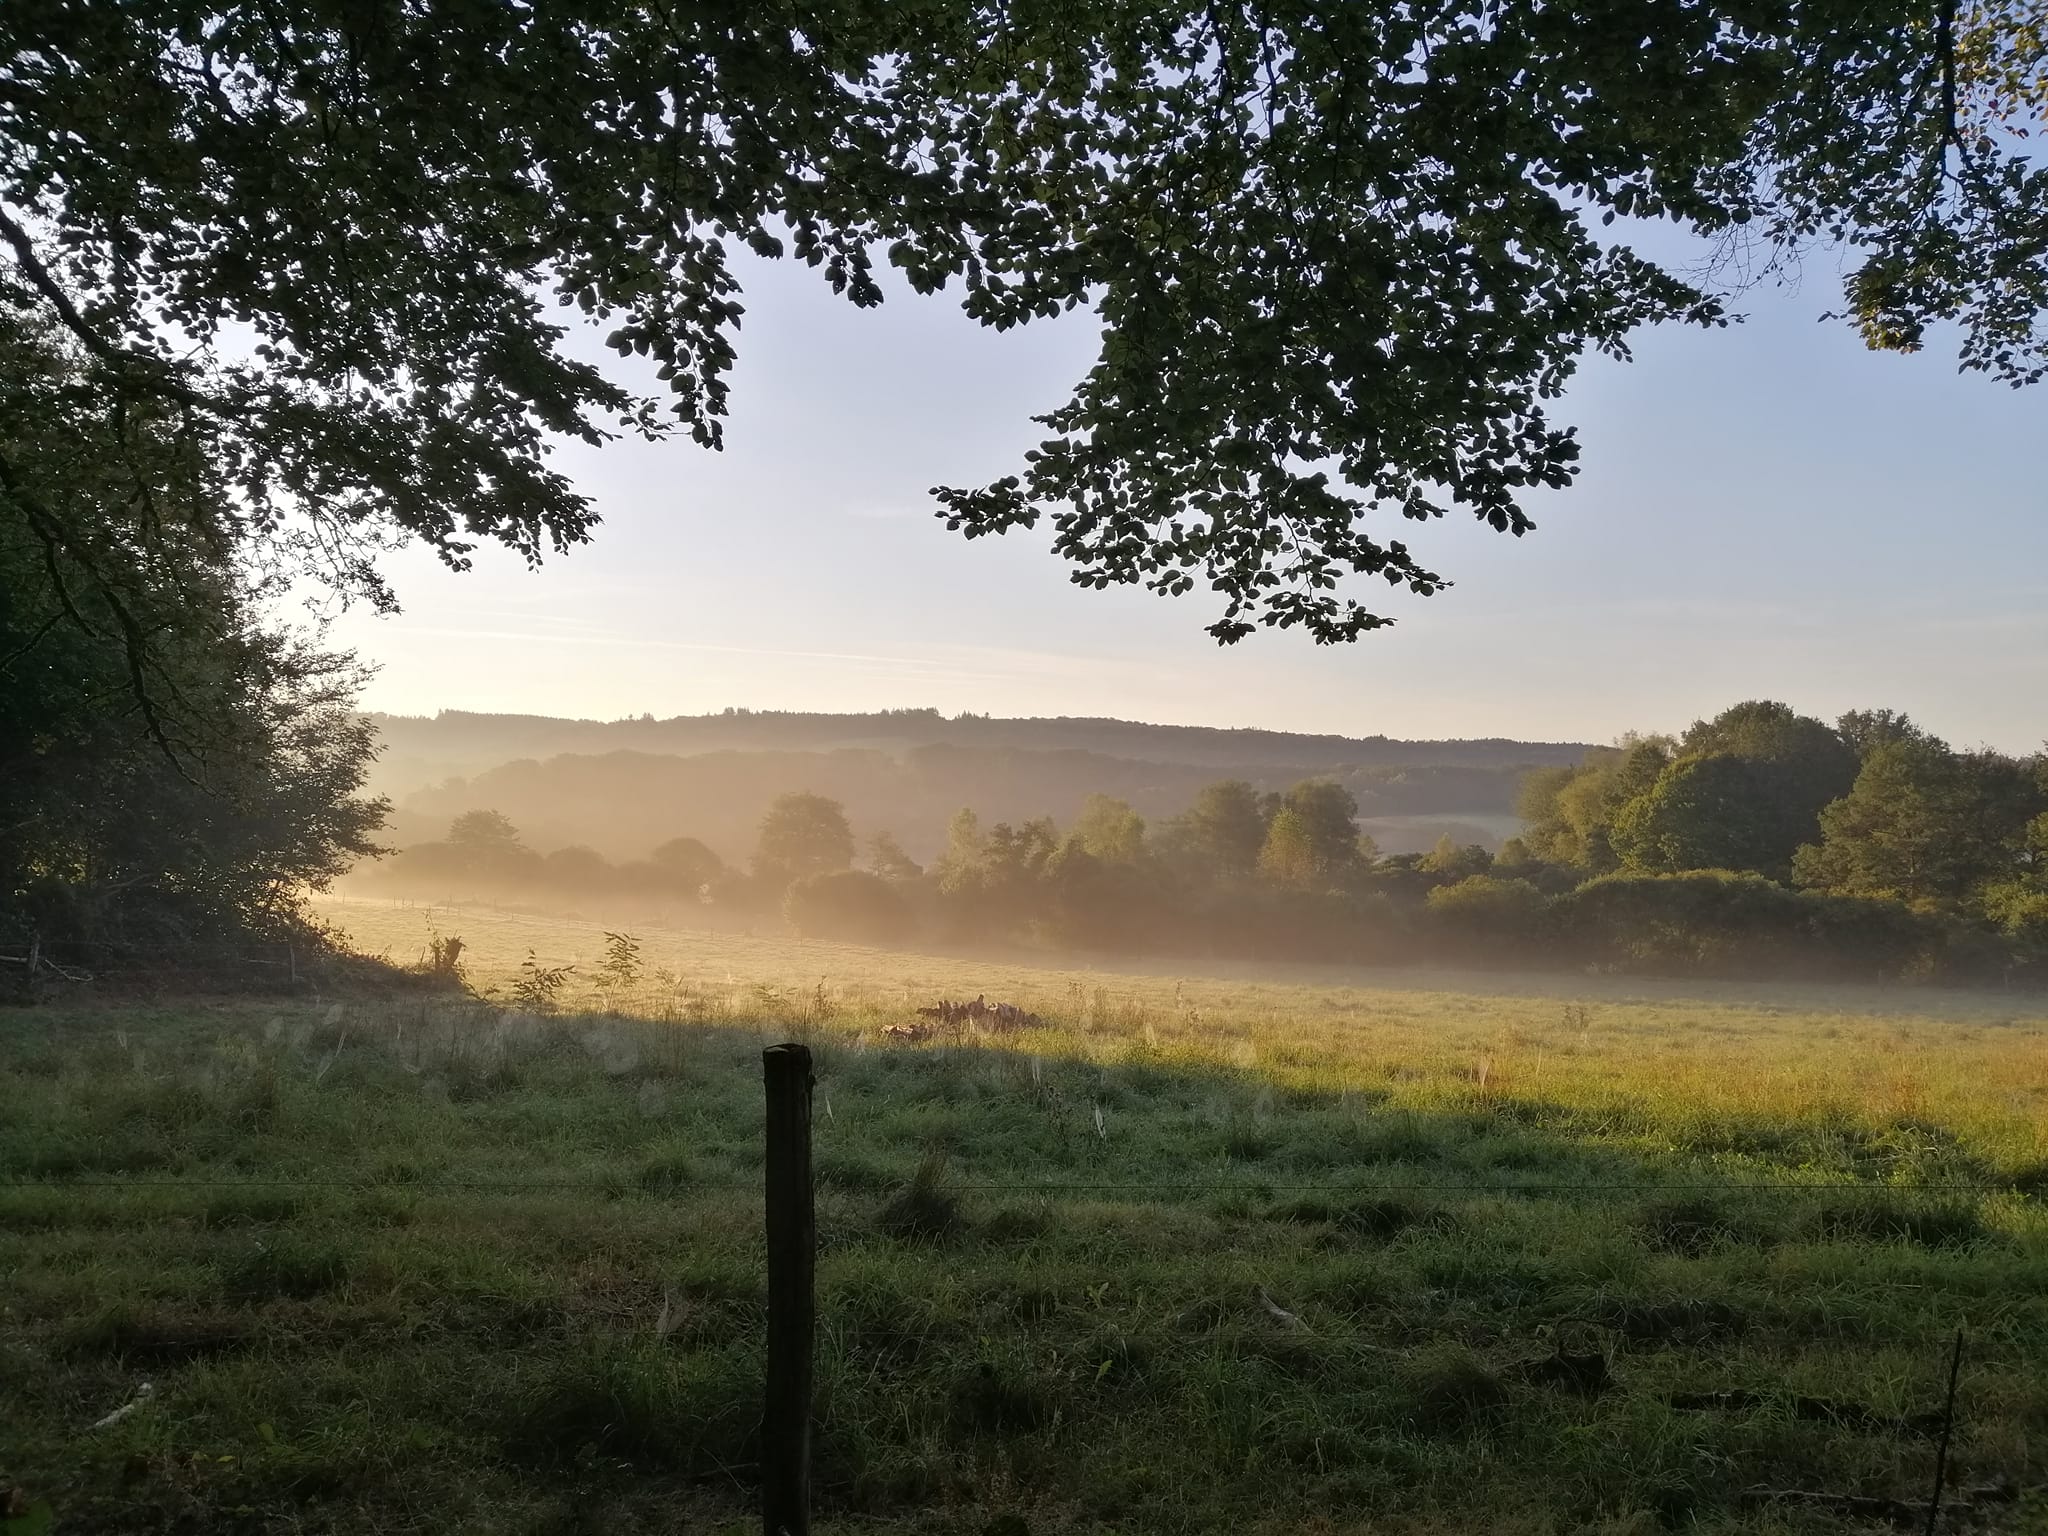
[375,711,1587,860]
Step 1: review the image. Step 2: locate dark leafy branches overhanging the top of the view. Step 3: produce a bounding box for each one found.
[0,0,2048,659]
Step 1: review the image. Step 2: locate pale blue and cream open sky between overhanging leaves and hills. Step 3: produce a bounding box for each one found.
[332,236,2048,752]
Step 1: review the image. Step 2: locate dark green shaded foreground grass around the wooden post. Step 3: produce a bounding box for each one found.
[0,1001,2048,1530]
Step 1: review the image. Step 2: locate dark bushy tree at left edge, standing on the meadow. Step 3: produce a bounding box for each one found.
[0,311,385,966]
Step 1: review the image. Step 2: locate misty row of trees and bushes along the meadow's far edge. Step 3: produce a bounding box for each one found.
[360,702,2048,981]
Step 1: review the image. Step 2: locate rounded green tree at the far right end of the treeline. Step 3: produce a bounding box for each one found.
[1794,735,2048,905]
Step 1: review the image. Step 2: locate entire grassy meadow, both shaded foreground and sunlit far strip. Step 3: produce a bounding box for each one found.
[0,903,2048,1534]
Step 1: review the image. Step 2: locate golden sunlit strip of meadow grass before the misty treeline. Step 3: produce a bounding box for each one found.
[324,901,2048,1165]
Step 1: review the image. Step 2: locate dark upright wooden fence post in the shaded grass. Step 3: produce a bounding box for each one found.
[762,1044,817,1536]
